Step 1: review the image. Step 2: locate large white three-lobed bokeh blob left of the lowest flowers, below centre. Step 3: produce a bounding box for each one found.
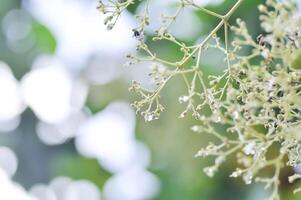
[75,102,141,172]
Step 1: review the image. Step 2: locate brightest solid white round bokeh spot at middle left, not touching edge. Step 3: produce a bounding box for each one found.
[22,59,72,123]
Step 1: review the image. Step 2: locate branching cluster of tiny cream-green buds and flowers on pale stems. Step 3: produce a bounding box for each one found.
[101,0,301,200]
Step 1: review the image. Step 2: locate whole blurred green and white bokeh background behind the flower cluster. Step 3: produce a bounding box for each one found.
[0,0,301,200]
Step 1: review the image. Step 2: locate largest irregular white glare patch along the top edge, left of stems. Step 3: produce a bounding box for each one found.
[26,0,135,68]
